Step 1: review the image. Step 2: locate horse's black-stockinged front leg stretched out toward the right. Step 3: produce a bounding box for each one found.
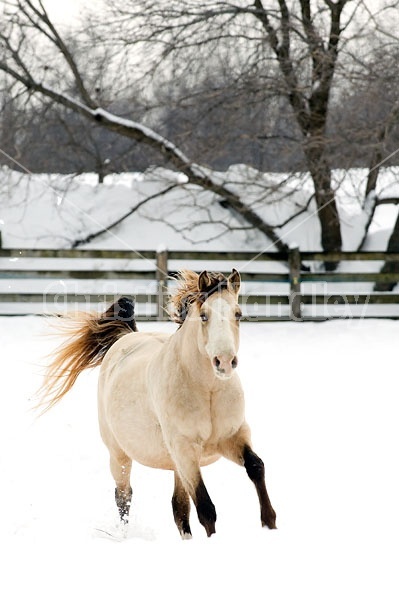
[219,424,276,529]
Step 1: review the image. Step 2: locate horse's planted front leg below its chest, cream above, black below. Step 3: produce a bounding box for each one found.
[170,438,216,537]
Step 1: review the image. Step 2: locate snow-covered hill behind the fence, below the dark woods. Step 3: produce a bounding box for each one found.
[0,165,399,251]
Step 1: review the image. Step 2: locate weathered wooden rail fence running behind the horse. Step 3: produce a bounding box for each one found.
[0,248,399,321]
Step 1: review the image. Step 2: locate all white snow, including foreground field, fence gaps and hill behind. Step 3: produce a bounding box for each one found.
[0,165,399,600]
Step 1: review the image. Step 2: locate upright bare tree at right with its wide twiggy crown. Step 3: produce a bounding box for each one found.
[103,0,399,268]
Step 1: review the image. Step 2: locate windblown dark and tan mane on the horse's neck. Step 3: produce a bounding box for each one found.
[170,269,228,325]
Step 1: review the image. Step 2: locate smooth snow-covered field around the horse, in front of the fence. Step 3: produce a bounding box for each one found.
[0,317,399,600]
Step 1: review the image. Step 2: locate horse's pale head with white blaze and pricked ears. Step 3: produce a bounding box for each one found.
[197,269,241,379]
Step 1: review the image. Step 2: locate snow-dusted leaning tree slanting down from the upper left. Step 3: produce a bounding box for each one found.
[0,0,287,251]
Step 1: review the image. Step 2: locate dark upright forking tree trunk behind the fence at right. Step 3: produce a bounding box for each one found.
[254,0,348,264]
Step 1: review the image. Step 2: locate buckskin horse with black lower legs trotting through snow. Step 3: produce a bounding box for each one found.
[42,269,276,539]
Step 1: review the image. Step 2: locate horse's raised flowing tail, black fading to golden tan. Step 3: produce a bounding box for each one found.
[37,297,137,413]
